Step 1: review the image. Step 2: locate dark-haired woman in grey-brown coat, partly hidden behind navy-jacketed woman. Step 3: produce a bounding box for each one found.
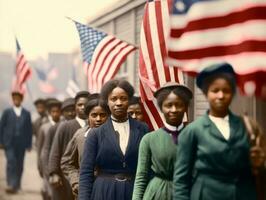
[61,93,109,198]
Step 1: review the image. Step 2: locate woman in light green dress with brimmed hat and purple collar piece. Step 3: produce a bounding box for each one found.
[132,83,192,200]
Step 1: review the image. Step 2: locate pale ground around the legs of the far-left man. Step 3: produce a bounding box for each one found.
[0,149,42,200]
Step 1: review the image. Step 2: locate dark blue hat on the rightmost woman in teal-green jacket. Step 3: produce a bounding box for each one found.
[196,63,236,89]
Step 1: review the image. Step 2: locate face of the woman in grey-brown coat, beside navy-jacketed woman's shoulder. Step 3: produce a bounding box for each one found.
[89,106,108,127]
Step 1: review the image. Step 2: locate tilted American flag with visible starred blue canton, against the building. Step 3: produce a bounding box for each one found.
[74,21,136,93]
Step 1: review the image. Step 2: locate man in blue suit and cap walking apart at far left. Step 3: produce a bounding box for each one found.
[0,92,32,193]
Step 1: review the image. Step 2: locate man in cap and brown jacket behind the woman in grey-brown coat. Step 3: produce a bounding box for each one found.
[48,91,90,200]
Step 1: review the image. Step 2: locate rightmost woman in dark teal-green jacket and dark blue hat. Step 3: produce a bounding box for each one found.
[173,63,257,200]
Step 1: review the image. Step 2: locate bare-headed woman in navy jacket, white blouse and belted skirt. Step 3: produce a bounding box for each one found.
[79,80,148,200]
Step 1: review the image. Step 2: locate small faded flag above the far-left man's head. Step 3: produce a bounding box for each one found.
[12,39,32,93]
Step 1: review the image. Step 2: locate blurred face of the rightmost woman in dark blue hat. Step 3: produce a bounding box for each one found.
[207,78,234,117]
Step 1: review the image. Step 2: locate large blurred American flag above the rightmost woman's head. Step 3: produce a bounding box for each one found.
[167,0,266,98]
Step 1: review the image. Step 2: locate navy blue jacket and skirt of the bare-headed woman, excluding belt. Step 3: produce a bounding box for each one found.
[79,118,149,200]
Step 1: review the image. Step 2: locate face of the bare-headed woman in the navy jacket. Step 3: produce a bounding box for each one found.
[108,87,128,120]
